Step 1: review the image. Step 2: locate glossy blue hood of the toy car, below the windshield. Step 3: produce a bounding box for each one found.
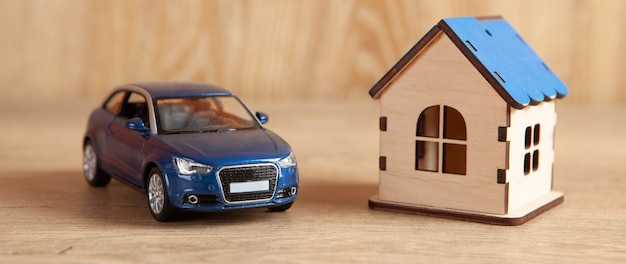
[159,129,291,165]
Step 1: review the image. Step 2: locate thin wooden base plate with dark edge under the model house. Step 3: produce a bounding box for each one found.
[369,191,565,226]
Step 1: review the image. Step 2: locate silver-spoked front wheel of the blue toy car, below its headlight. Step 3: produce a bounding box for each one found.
[146,168,177,222]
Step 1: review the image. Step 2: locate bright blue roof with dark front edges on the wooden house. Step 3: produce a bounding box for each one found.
[370,17,568,109]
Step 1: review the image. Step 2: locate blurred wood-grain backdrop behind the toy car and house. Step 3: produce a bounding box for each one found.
[0,0,626,104]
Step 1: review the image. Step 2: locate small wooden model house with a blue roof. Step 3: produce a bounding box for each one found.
[369,17,568,225]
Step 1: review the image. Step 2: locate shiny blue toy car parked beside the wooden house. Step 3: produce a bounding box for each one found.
[83,82,298,221]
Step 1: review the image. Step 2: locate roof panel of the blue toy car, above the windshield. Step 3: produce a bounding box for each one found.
[122,81,233,99]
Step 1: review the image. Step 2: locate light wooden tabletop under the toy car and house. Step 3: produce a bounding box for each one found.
[0,100,626,263]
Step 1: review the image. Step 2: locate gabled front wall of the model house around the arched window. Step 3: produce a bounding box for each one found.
[378,33,507,214]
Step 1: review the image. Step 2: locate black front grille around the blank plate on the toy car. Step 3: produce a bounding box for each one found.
[217,163,278,203]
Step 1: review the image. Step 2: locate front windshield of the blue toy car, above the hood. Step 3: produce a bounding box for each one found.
[155,96,260,134]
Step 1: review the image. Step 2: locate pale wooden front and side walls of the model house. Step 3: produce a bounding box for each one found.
[370,25,556,215]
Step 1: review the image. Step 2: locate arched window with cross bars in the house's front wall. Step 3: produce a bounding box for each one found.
[415,105,467,175]
